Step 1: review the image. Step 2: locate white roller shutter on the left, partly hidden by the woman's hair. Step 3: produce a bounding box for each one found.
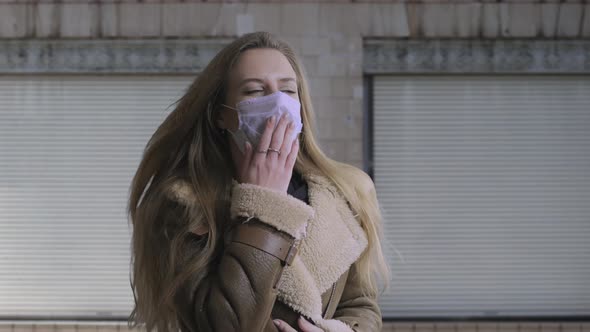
[0,76,192,317]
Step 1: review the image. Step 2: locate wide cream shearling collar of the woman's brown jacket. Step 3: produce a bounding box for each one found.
[168,172,368,322]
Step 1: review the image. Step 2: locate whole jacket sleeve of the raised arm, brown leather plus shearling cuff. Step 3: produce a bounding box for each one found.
[178,183,313,332]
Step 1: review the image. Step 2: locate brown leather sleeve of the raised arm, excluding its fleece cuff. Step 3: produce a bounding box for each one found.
[191,221,283,331]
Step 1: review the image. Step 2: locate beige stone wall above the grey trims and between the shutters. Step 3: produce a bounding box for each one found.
[0,0,590,167]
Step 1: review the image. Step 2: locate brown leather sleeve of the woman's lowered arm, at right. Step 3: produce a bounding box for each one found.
[333,264,383,332]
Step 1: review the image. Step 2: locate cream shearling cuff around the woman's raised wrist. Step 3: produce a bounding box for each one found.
[231,180,314,239]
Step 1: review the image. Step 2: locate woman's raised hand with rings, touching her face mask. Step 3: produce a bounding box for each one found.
[233,113,299,192]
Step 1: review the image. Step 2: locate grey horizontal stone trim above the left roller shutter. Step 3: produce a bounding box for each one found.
[0,39,231,74]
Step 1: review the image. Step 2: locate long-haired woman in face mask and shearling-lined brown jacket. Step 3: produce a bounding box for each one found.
[129,32,387,332]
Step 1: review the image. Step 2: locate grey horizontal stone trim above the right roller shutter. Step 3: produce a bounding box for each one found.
[363,39,590,74]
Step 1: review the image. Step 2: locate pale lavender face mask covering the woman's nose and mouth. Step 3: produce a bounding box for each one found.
[222,91,303,153]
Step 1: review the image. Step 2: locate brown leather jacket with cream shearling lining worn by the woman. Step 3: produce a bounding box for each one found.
[164,172,382,332]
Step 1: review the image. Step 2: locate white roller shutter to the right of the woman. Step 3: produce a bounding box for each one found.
[373,76,590,317]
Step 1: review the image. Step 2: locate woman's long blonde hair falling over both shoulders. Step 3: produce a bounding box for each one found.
[128,32,389,332]
